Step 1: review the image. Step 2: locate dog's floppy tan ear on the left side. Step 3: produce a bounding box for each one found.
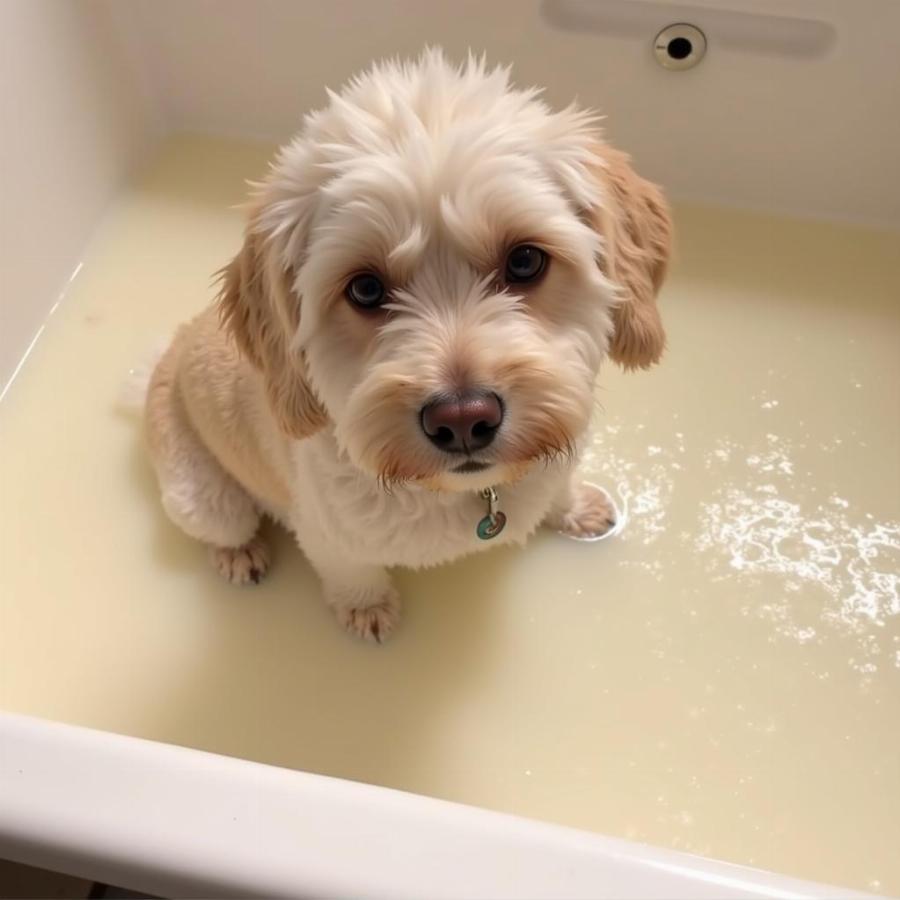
[218,221,328,438]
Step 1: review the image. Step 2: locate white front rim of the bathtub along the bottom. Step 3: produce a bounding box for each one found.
[0,715,865,900]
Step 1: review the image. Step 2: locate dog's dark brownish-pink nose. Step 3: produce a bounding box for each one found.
[421,391,503,453]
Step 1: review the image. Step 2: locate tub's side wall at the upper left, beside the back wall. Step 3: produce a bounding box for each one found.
[0,0,160,390]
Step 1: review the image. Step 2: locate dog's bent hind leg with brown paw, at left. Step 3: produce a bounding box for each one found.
[147,372,269,584]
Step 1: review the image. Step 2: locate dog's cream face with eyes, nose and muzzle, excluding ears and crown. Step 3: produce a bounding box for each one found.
[297,115,611,489]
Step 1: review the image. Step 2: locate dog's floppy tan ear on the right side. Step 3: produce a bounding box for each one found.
[597,144,672,369]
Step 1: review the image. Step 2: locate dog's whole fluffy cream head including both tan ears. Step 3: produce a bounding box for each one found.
[220,52,670,490]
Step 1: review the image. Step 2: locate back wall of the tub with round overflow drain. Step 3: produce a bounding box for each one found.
[109,0,900,227]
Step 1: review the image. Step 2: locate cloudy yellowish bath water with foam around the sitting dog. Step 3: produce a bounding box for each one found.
[0,139,900,893]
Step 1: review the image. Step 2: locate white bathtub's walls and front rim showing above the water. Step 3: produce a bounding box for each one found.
[0,0,900,898]
